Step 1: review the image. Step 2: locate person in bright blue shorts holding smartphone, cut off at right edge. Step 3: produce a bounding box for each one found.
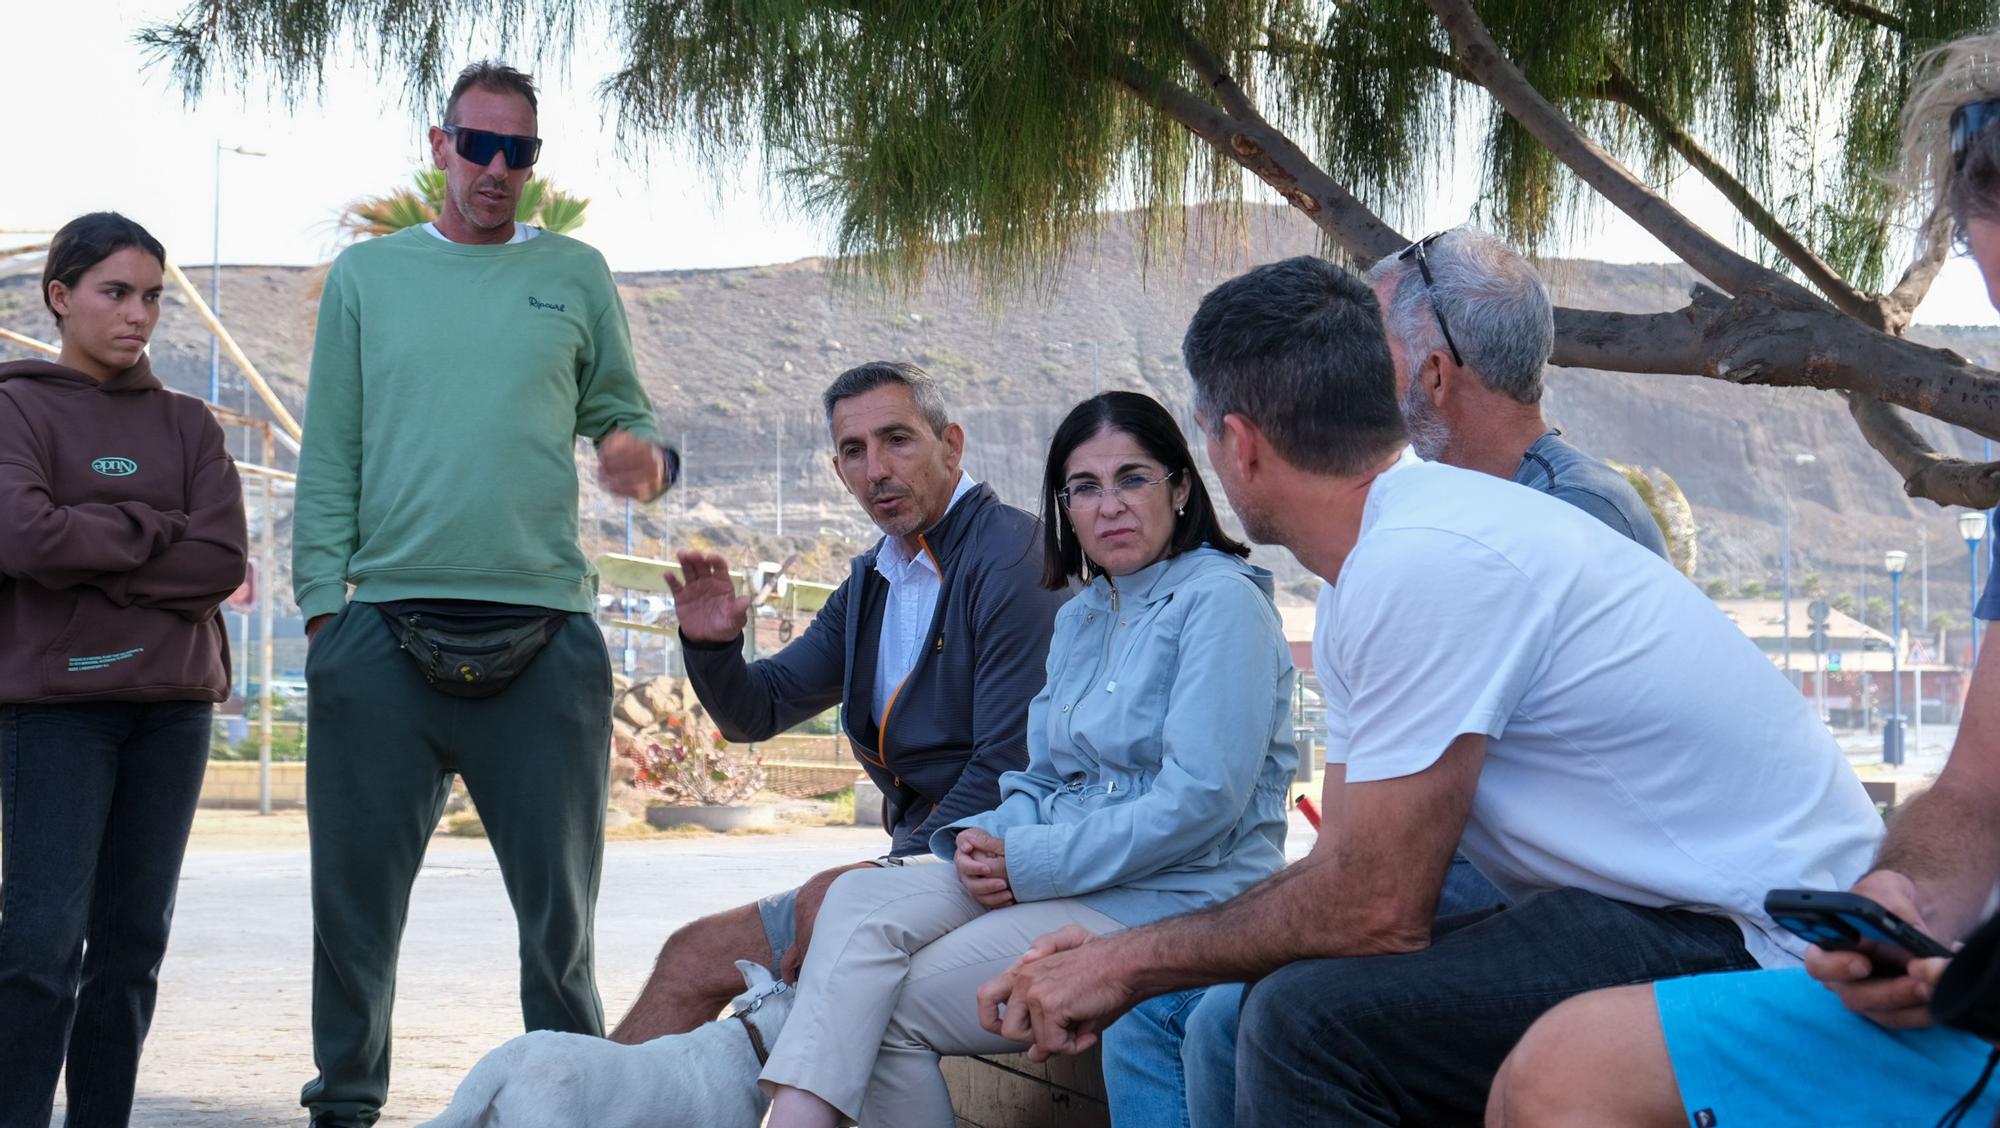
[1486,28,2000,1128]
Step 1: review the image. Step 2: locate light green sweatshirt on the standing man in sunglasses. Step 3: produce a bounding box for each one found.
[292,228,658,620]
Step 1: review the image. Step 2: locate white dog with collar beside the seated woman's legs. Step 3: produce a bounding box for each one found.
[424,960,796,1128]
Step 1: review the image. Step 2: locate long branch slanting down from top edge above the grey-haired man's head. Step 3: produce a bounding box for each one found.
[1426,0,1822,306]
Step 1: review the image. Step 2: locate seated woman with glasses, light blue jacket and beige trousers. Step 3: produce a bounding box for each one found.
[762,392,1298,1128]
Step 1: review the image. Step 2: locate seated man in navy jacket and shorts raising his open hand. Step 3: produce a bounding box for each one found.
[612,362,1068,1042]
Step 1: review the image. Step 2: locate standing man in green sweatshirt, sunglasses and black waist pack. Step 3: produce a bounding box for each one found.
[292,62,678,1128]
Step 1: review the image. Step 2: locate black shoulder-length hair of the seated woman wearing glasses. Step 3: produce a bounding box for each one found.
[1042,392,1250,592]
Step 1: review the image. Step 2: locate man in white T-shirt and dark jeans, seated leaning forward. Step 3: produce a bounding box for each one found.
[980,258,1882,1124]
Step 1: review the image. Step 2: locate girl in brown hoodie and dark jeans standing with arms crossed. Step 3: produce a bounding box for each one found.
[0,212,246,1128]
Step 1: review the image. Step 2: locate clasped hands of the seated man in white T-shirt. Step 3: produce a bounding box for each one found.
[978,924,1138,1062]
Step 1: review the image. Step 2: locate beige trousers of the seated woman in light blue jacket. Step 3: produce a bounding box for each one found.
[758,864,1124,1128]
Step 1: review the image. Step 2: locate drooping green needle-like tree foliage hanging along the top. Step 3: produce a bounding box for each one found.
[138,0,1996,288]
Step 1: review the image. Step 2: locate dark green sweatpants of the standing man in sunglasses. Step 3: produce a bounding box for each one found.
[300,602,612,1124]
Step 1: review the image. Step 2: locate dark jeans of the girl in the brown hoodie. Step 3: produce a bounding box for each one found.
[0,702,214,1128]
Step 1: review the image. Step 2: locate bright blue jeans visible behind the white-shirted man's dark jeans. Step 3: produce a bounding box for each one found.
[1104,854,1506,1128]
